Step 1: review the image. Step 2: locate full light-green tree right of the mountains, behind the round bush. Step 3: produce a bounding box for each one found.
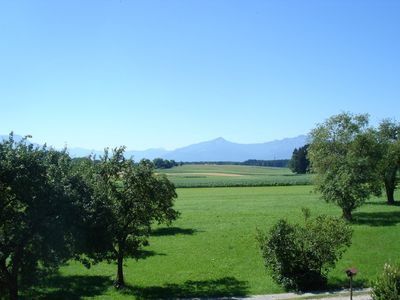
[308,113,380,220]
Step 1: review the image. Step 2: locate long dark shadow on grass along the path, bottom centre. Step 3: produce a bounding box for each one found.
[121,277,248,299]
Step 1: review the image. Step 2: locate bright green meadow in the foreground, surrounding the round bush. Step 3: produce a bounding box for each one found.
[27,186,400,299]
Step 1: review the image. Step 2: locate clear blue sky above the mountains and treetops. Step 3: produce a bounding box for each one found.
[0,0,400,150]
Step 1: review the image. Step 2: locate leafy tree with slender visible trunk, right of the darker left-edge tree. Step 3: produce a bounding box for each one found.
[83,147,178,288]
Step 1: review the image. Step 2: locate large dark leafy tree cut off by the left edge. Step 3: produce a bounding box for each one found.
[0,134,90,299]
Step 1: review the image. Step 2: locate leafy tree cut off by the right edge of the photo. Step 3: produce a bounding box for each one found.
[376,120,400,204]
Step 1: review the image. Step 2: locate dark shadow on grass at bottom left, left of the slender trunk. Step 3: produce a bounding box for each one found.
[21,275,113,300]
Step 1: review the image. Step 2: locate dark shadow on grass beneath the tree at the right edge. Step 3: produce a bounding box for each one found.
[353,211,400,226]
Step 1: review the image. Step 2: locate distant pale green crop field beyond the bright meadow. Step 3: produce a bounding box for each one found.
[158,165,311,187]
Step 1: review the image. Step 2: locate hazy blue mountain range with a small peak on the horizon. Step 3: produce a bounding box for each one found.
[0,135,307,162]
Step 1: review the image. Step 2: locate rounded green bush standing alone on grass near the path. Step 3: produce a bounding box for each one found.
[258,210,352,290]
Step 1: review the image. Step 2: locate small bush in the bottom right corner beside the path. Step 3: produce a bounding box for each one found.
[372,264,400,300]
